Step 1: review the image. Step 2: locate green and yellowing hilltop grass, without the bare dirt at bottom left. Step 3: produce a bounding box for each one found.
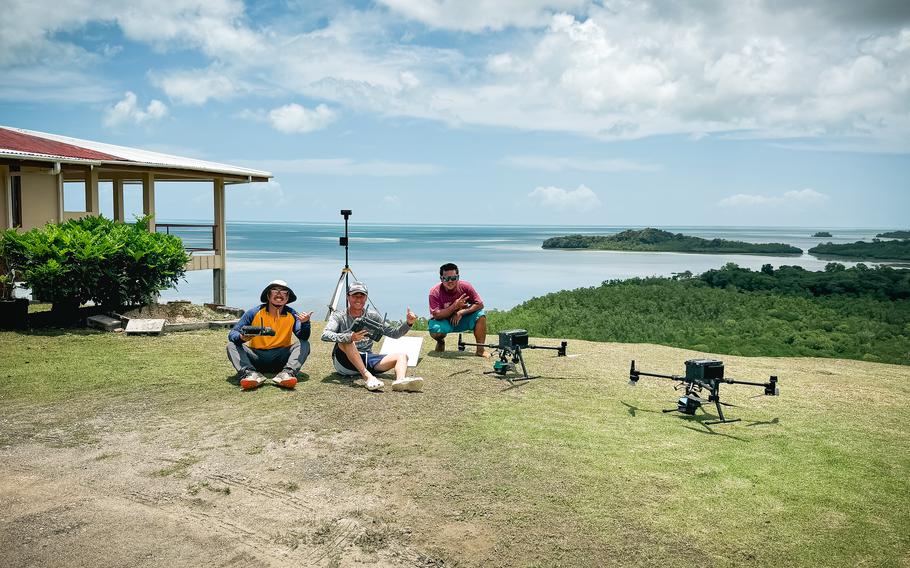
[0,324,910,566]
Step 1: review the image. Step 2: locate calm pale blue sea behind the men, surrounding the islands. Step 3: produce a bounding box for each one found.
[162,220,900,319]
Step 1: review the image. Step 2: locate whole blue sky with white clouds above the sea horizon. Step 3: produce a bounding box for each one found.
[0,0,910,228]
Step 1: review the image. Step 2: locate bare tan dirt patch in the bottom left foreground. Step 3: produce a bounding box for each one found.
[0,404,452,568]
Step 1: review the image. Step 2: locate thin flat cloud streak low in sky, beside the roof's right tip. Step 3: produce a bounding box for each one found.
[249,158,443,177]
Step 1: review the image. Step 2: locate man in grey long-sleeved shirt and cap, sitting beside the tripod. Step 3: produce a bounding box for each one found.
[322,281,423,392]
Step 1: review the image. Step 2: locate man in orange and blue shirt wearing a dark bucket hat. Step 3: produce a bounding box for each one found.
[227,280,313,390]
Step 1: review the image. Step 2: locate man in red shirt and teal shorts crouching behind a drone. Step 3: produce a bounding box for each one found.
[428,262,488,357]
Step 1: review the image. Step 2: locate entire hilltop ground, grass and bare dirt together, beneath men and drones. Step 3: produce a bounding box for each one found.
[0,326,910,567]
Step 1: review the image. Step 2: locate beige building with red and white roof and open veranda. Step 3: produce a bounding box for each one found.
[0,126,272,304]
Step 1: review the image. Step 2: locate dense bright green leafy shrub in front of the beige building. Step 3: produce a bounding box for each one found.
[0,217,189,312]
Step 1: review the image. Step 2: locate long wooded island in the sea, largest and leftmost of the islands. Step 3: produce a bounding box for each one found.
[543,228,803,254]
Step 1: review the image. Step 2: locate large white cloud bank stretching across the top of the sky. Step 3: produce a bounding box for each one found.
[7,0,910,150]
